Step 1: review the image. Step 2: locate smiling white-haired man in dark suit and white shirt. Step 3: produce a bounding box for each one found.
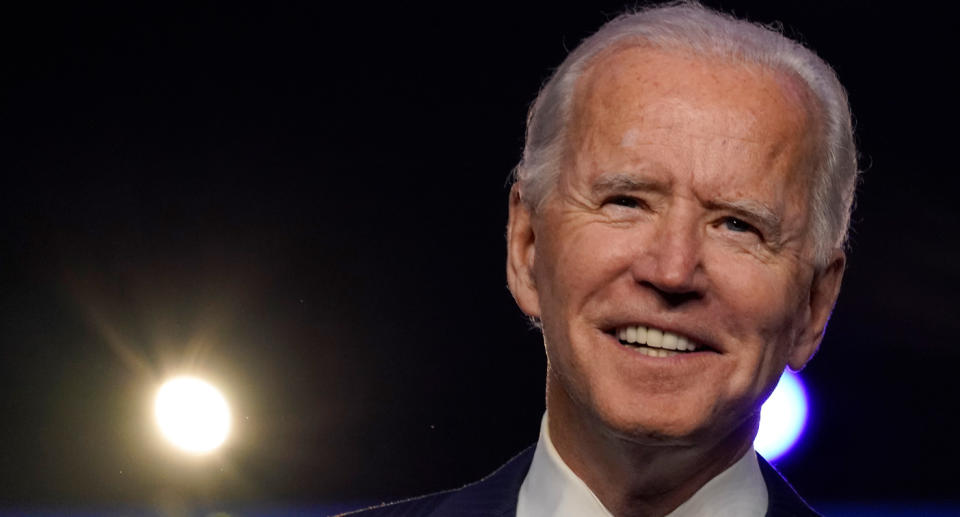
[344,4,857,517]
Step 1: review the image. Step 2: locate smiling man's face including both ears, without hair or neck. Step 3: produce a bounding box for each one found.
[508,48,843,444]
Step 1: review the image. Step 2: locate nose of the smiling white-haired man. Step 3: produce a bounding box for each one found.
[633,210,706,306]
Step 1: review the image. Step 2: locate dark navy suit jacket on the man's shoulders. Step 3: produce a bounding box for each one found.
[345,447,819,517]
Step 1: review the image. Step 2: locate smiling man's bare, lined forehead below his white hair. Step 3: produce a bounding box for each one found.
[568,46,815,187]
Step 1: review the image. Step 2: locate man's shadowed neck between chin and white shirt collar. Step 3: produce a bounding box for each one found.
[547,374,759,517]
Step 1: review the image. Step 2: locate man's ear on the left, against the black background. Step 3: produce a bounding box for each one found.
[507,183,540,318]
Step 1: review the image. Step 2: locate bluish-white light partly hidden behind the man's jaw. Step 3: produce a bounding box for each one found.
[753,370,807,461]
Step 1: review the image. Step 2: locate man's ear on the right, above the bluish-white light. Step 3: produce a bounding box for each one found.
[787,250,847,371]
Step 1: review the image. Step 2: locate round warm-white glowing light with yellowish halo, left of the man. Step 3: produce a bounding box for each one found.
[154,377,230,453]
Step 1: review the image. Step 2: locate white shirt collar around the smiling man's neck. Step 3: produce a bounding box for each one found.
[517,414,767,517]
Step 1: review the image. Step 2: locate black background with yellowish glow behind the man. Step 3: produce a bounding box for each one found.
[0,1,960,511]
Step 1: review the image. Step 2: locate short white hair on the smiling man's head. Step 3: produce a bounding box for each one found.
[514,2,858,266]
